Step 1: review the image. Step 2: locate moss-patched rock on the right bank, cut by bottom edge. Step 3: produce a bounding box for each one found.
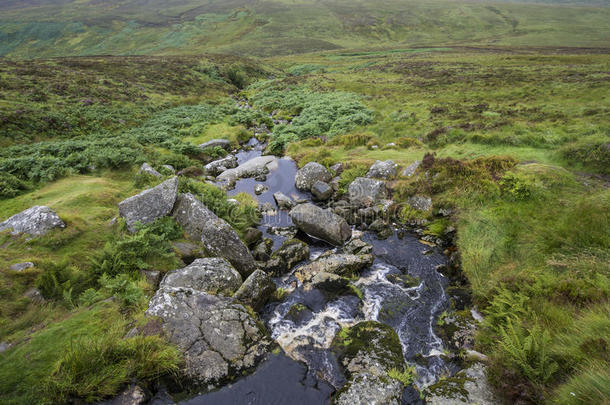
[424,363,500,405]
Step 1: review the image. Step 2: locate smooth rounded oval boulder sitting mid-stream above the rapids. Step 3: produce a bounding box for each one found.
[290,203,352,245]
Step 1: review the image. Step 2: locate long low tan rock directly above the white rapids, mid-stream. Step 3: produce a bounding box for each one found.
[295,254,373,282]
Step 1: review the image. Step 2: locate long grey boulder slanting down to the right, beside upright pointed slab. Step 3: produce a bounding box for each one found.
[172,194,256,277]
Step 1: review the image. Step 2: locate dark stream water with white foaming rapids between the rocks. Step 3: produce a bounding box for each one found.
[180,140,448,404]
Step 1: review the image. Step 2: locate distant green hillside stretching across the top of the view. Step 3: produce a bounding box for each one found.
[0,0,610,58]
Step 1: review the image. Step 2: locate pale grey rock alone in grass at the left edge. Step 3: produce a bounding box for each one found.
[0,205,66,236]
